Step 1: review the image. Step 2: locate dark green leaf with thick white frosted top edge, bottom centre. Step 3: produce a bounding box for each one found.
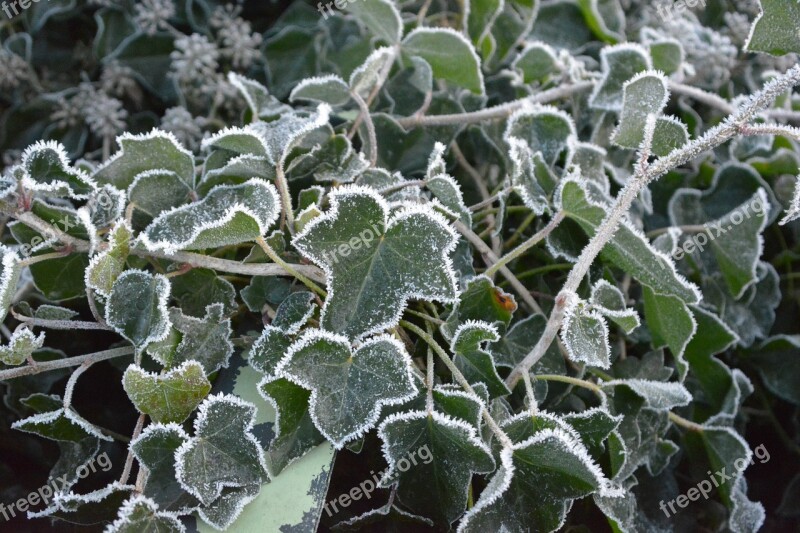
[378,411,495,524]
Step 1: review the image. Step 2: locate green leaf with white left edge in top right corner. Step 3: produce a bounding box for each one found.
[744,0,800,56]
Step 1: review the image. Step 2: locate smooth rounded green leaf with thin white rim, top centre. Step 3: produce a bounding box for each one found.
[402,28,484,94]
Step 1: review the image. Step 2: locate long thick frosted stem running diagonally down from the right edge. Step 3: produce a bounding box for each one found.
[506,65,800,387]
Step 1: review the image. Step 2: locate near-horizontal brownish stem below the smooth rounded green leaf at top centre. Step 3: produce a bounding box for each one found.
[397,81,594,128]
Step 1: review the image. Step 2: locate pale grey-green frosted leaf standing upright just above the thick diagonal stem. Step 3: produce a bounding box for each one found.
[611,71,669,149]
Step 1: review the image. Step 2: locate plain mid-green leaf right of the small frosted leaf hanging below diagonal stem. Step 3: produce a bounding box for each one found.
[642,287,697,381]
